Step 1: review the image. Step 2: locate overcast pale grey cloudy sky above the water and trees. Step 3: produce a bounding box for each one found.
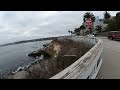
[0,11,118,44]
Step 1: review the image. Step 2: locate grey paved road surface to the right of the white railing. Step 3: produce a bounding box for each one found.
[97,38,120,79]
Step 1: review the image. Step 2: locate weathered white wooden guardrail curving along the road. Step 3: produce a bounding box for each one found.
[50,36,103,79]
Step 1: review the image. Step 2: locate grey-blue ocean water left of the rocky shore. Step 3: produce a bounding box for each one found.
[0,40,52,78]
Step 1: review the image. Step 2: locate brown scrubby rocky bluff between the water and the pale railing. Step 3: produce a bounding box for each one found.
[5,39,93,79]
